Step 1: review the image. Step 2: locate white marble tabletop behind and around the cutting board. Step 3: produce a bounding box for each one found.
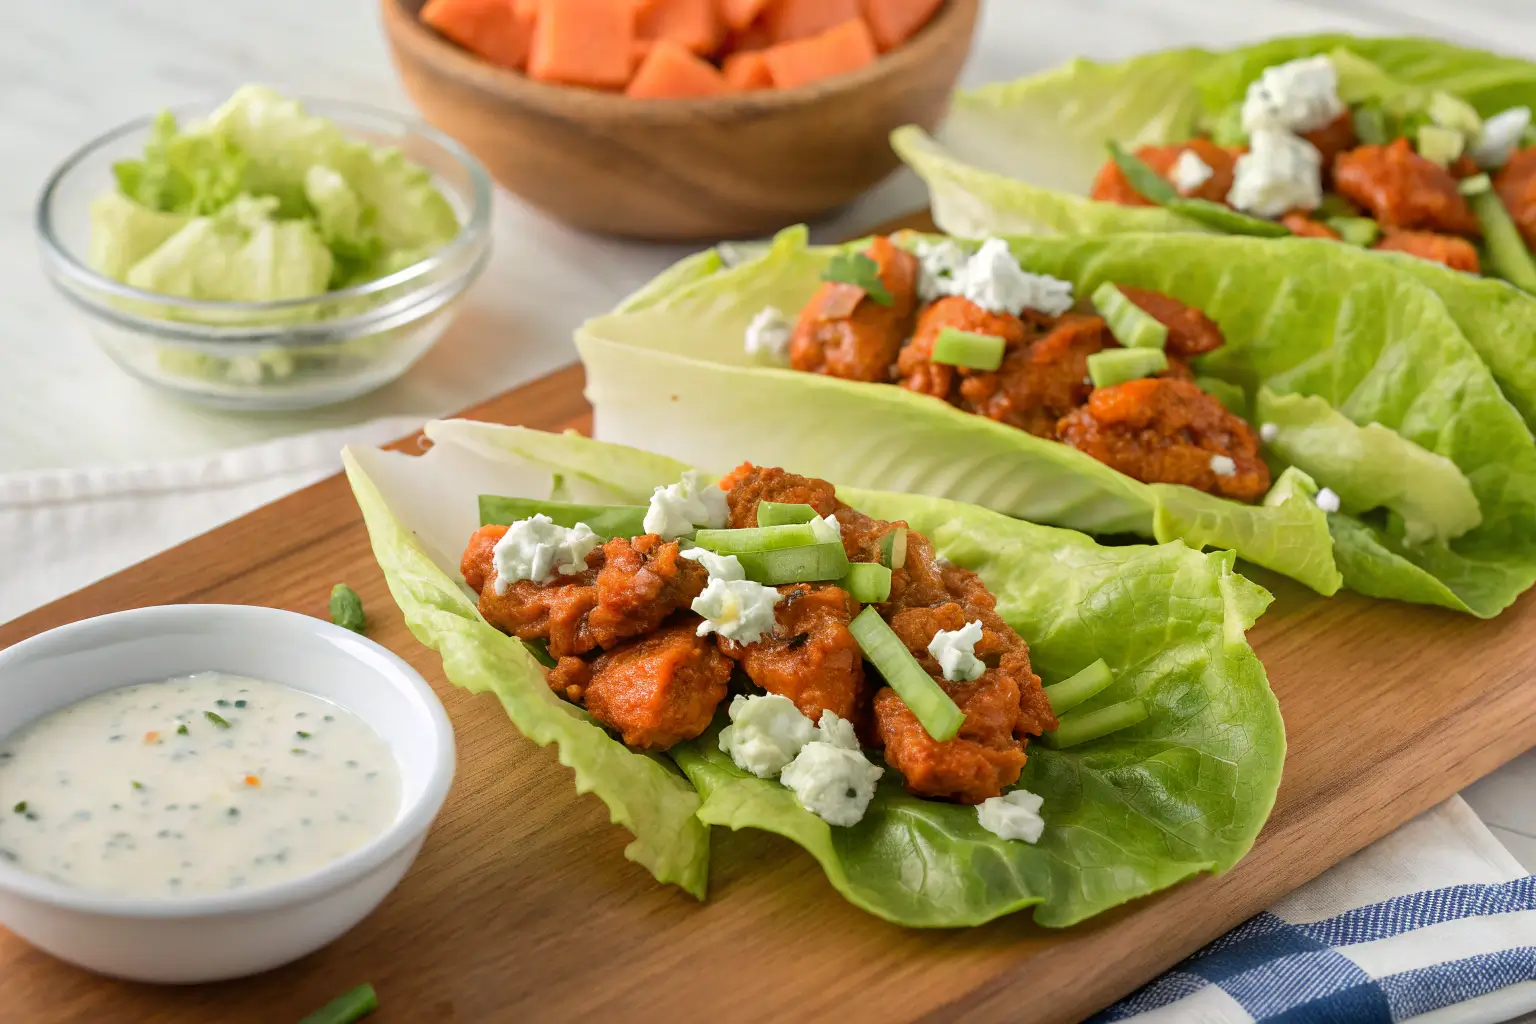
[0,0,1536,867]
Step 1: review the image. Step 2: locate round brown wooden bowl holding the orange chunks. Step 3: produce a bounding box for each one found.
[379,0,978,241]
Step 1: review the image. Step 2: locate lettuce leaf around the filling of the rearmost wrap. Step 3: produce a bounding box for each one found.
[891,35,1536,424]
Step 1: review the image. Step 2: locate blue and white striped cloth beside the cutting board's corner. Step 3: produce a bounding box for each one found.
[1092,797,1536,1024]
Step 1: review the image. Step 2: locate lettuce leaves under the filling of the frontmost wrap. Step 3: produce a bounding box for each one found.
[344,421,1286,927]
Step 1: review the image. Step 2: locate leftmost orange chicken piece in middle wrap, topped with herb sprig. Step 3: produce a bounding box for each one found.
[790,236,917,381]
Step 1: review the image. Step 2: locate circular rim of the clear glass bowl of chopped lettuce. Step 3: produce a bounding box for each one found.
[32,94,495,316]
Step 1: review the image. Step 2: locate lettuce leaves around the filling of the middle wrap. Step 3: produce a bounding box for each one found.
[578,229,1536,617]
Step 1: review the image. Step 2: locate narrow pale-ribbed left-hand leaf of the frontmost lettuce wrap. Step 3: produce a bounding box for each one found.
[343,442,710,900]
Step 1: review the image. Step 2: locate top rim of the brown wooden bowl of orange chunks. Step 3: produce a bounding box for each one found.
[379,0,980,126]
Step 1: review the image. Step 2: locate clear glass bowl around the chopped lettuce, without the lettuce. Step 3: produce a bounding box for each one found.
[37,97,492,410]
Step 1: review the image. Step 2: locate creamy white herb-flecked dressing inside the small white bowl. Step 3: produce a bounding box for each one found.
[0,672,399,897]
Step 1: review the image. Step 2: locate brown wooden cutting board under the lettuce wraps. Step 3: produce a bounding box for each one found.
[0,221,1536,1024]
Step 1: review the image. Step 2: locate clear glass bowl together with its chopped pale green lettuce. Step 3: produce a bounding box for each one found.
[37,86,492,410]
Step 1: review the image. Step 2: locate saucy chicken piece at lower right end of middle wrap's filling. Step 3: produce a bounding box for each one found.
[1058,378,1270,502]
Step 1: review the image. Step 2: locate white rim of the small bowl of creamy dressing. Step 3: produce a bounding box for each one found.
[0,605,456,920]
